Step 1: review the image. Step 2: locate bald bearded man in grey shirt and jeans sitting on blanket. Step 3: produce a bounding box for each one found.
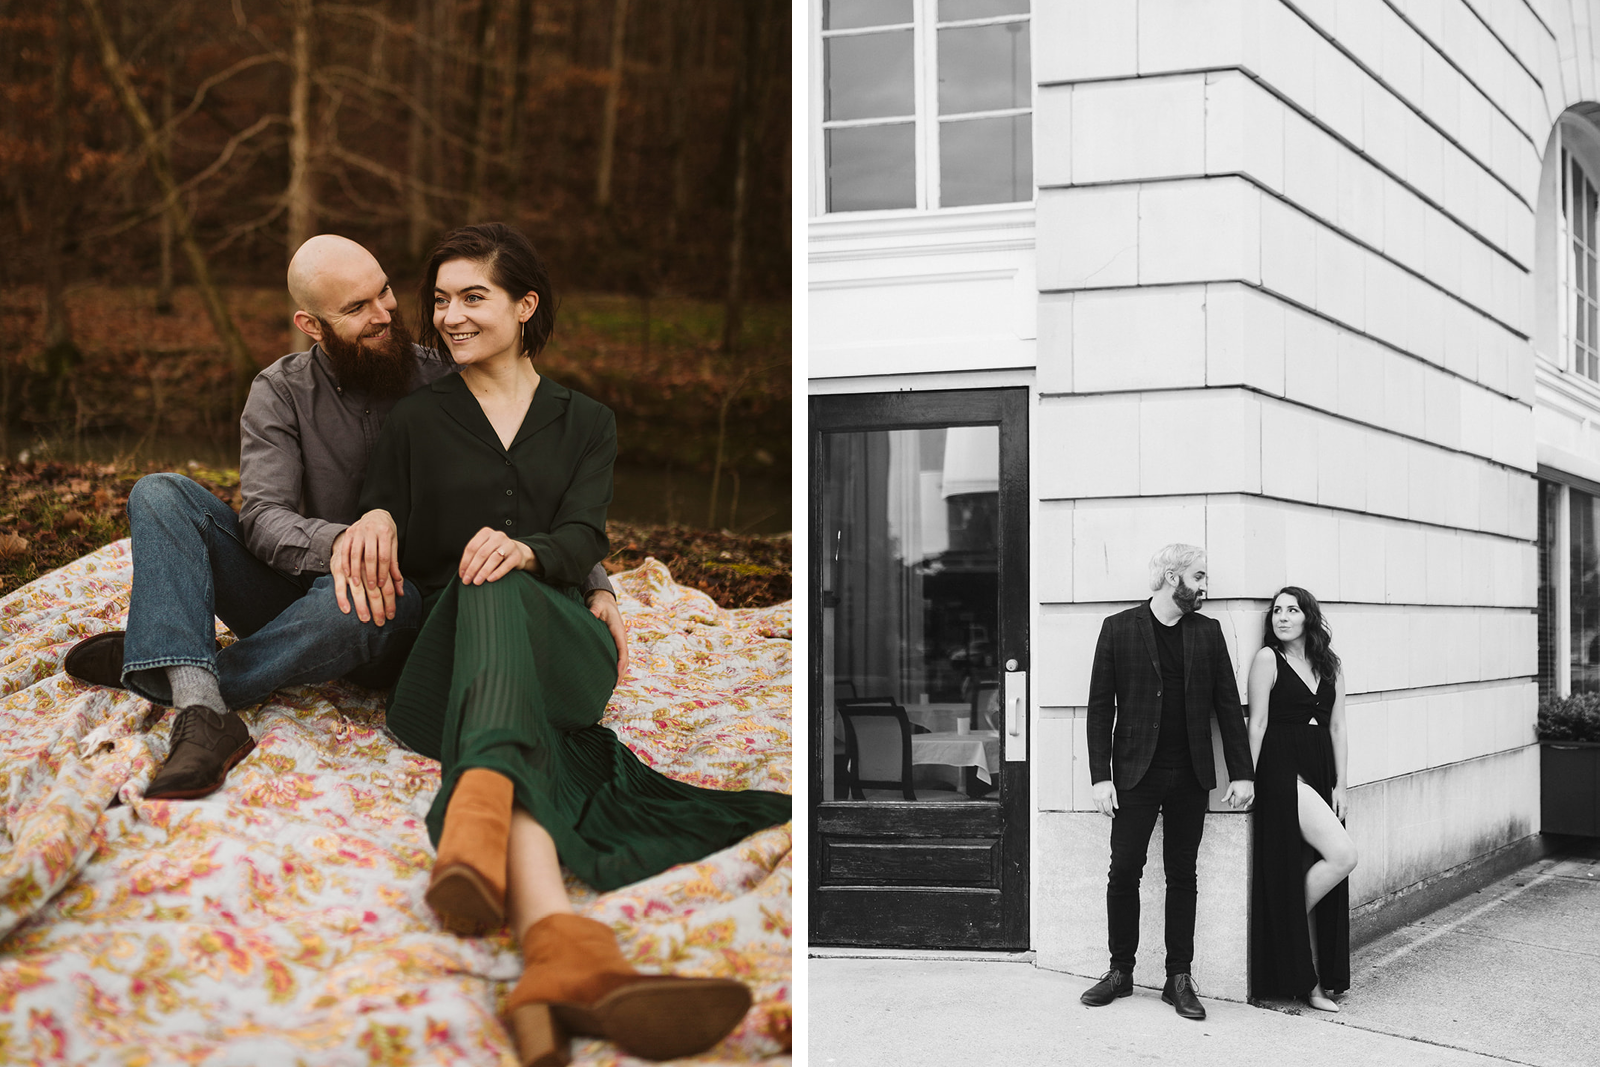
[62,234,627,800]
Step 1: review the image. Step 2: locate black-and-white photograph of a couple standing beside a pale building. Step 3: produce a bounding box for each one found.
[812,0,1600,1067]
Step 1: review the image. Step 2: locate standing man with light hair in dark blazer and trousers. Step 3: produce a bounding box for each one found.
[1082,544,1254,1019]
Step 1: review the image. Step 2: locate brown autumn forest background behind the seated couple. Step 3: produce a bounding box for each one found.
[0,0,792,601]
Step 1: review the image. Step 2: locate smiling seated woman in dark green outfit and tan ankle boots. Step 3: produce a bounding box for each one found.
[362,222,790,1067]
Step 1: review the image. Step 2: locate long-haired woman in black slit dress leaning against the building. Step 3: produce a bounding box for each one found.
[1250,585,1357,1011]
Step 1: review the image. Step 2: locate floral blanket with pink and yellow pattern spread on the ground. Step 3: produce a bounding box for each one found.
[0,541,792,1067]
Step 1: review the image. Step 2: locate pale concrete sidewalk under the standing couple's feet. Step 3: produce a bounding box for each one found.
[806,841,1600,1067]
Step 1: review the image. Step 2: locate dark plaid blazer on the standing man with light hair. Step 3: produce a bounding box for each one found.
[1088,600,1254,789]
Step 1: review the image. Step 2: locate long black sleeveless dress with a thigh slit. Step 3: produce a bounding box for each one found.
[1250,649,1350,997]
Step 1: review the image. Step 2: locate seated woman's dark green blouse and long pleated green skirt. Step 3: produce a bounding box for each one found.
[362,374,790,891]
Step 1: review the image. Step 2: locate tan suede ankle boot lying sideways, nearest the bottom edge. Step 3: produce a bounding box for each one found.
[507,913,750,1067]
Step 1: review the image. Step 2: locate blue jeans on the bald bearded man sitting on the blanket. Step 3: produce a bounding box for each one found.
[122,474,422,709]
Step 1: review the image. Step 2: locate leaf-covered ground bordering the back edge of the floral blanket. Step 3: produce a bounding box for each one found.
[0,462,794,608]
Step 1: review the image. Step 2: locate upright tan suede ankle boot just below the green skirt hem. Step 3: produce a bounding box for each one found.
[424,768,512,937]
